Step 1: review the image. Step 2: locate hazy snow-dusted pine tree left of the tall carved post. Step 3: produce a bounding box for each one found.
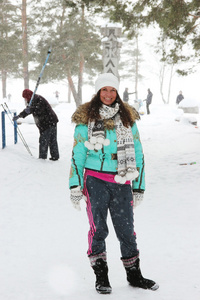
[33,0,102,106]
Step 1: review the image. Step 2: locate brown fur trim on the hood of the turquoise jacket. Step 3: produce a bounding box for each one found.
[72,102,140,130]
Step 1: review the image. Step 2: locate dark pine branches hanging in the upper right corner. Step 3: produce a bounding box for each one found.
[110,0,200,75]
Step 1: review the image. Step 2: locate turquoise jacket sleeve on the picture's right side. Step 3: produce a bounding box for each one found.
[132,123,145,191]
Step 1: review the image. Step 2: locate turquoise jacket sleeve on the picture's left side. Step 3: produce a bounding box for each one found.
[69,125,88,189]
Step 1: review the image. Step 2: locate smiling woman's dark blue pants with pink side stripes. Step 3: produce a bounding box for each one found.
[85,176,139,258]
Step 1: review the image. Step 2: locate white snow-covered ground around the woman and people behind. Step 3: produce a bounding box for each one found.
[0,92,200,300]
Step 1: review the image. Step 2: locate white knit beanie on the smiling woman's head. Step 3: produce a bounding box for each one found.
[95,73,119,93]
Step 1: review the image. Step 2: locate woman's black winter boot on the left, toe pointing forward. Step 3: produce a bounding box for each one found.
[92,258,112,294]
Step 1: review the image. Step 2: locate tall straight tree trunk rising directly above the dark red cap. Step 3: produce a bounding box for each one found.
[22,0,29,89]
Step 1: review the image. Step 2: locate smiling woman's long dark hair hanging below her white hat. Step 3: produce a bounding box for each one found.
[88,90,133,127]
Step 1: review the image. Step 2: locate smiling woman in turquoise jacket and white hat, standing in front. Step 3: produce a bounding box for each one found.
[69,73,158,294]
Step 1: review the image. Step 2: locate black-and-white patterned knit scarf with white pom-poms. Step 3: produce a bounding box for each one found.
[85,103,138,184]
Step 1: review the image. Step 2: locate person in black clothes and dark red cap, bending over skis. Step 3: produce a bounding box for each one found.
[13,89,59,161]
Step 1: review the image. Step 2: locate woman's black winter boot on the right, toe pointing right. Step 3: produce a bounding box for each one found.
[122,258,159,291]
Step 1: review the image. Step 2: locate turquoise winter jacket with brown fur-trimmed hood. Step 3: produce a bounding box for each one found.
[69,103,145,191]
